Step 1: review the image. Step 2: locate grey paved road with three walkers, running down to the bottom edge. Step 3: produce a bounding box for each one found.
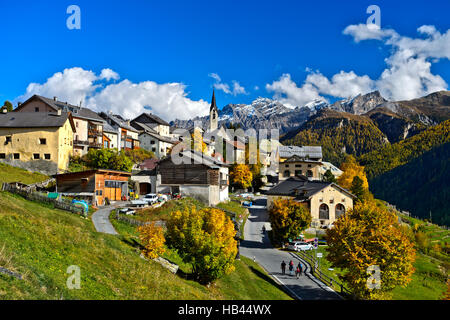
[240,198,341,300]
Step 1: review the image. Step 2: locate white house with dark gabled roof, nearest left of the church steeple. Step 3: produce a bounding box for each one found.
[131,113,177,158]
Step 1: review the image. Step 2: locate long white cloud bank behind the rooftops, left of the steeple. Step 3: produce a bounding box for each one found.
[15,68,209,121]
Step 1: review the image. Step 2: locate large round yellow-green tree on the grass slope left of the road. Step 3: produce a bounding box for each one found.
[166,207,237,284]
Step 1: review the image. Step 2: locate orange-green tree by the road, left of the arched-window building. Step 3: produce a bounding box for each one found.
[269,199,311,242]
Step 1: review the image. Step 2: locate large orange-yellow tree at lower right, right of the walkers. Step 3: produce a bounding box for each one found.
[327,202,415,299]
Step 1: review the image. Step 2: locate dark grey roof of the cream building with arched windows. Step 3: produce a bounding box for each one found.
[266,176,355,201]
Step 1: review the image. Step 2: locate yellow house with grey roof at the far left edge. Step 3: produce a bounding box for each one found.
[0,109,76,174]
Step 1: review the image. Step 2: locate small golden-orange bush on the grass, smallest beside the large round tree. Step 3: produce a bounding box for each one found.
[138,222,165,259]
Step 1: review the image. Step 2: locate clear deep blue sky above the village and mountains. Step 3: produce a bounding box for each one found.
[0,0,450,120]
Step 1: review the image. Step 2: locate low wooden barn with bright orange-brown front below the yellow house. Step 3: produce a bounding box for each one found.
[54,169,131,206]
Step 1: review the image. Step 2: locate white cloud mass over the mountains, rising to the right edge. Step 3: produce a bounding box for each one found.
[266,24,450,105]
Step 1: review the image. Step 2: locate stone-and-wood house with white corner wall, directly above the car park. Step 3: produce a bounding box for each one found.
[156,150,229,205]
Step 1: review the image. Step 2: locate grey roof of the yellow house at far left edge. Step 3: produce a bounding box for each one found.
[0,112,76,132]
